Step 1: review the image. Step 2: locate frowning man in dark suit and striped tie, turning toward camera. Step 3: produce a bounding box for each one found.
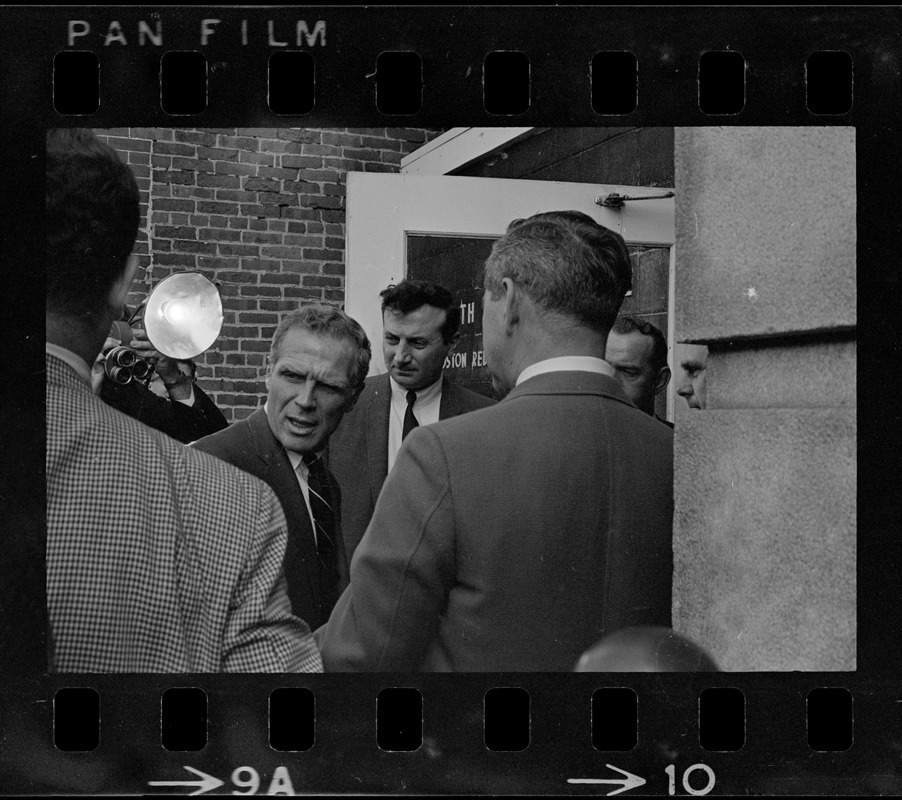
[193,304,370,628]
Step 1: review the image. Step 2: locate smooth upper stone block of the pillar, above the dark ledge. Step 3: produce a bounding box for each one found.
[675,127,856,342]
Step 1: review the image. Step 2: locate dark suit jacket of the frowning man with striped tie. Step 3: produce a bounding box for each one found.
[192,408,348,628]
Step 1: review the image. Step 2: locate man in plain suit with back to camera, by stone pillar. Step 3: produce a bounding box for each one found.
[316,211,673,672]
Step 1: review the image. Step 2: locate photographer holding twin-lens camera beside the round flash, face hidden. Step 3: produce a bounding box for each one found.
[93,309,228,444]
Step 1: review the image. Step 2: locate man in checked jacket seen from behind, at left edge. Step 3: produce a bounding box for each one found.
[46,130,322,672]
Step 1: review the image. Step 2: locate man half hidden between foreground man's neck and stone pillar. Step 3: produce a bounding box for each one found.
[604,317,673,428]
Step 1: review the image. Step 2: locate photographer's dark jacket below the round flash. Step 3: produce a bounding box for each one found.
[100,377,229,444]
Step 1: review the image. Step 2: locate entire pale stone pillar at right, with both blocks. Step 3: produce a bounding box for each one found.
[673,127,856,671]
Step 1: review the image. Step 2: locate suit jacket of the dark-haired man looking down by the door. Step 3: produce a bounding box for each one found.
[328,373,496,561]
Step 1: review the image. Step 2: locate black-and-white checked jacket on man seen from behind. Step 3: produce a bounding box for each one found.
[46,354,322,672]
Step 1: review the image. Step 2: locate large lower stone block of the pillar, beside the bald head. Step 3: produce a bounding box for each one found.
[673,408,856,671]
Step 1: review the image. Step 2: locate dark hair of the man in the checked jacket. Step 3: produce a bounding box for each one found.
[46,128,141,316]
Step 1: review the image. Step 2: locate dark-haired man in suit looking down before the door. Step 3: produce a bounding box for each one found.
[328,280,495,561]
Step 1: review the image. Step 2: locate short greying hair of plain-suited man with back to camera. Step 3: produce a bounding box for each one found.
[484,211,632,333]
